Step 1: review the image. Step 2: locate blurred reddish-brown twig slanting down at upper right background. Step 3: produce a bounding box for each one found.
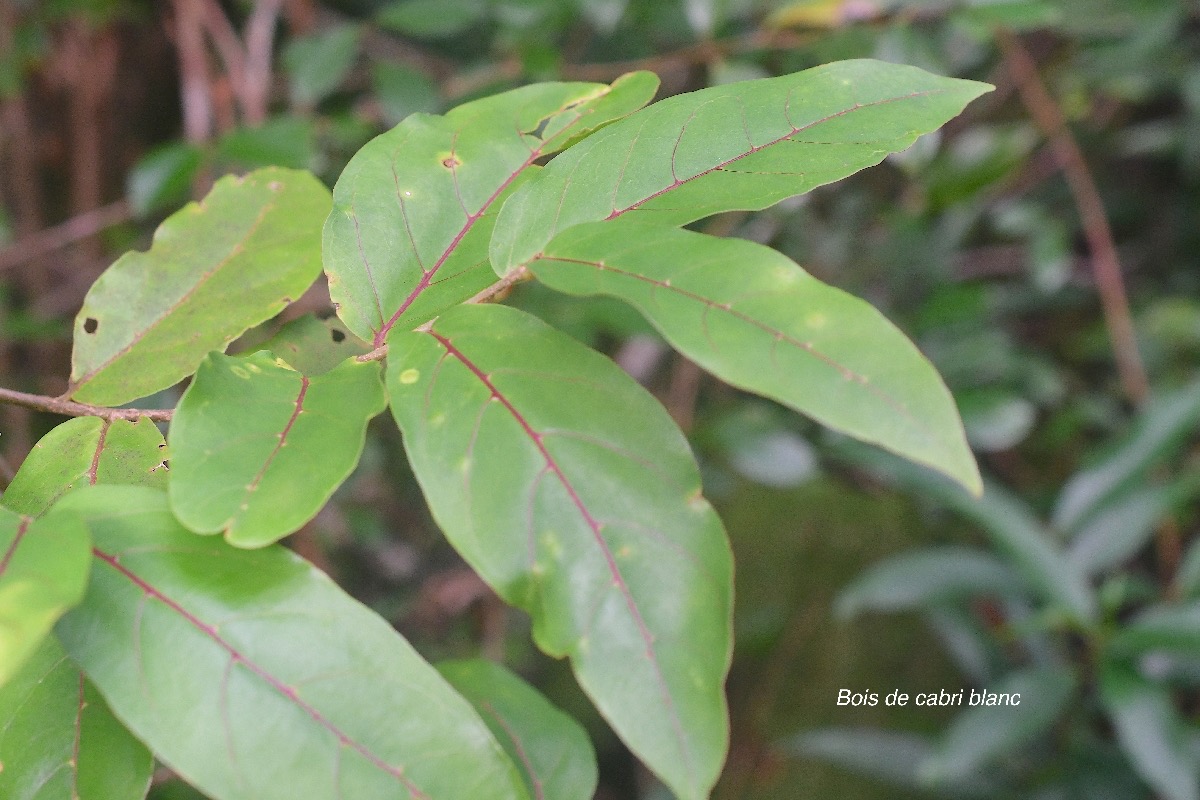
[996,29,1150,405]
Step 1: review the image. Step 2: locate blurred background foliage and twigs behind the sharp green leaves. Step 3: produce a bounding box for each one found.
[0,0,1200,800]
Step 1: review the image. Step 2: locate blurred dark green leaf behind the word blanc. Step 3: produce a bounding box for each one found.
[920,667,1075,783]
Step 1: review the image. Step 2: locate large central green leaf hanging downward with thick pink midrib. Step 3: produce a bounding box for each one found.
[388,306,732,800]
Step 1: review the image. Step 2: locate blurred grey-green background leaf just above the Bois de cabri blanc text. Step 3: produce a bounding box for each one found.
[834,547,1024,618]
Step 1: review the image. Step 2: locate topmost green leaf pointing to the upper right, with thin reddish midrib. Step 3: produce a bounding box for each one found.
[491,60,991,275]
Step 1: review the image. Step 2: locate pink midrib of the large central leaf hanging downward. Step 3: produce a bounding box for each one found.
[428,330,689,758]
